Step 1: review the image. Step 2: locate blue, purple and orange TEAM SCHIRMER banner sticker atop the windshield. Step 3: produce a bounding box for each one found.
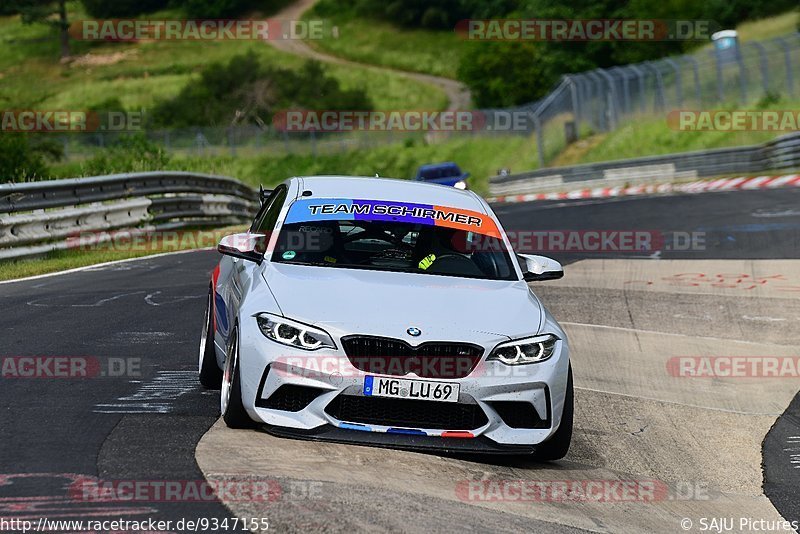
[286,198,500,238]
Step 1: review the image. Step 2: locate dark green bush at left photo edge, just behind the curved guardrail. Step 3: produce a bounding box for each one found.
[0,132,63,182]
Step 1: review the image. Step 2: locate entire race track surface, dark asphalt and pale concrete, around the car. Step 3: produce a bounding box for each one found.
[0,190,800,532]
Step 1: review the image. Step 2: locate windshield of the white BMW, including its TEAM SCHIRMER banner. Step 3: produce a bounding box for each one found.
[272,200,516,280]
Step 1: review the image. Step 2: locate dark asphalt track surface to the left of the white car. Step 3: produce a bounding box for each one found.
[0,252,229,532]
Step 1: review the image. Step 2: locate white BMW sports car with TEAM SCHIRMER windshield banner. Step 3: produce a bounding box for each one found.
[199,177,573,460]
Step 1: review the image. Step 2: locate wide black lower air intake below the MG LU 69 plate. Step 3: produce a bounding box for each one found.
[325,395,488,430]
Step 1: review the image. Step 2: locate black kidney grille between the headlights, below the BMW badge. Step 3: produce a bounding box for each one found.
[342,336,483,378]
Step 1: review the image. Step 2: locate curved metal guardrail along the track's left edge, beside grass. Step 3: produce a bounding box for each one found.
[0,172,259,259]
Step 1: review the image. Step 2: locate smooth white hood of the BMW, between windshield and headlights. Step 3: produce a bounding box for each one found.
[263,263,543,345]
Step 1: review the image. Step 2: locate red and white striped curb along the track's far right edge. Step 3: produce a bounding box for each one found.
[486,174,800,204]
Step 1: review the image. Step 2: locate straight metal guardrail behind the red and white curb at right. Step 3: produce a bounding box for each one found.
[489,132,800,197]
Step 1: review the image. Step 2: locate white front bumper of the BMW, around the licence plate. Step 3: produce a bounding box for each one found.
[234,321,569,454]
